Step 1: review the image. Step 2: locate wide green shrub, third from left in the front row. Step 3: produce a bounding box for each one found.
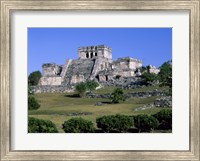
[96,114,133,133]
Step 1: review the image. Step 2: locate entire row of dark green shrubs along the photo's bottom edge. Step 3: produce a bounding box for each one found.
[28,109,172,133]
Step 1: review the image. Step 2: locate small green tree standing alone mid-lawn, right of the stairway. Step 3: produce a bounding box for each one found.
[110,88,125,103]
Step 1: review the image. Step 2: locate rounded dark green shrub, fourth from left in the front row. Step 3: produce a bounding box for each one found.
[133,114,159,132]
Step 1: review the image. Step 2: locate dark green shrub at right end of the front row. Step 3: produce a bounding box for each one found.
[153,109,172,130]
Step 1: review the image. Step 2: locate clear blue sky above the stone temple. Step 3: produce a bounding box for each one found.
[28,28,172,74]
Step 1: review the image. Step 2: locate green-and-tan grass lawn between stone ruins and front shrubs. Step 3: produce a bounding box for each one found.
[29,87,169,132]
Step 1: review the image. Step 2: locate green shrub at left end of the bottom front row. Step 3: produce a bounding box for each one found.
[28,117,58,133]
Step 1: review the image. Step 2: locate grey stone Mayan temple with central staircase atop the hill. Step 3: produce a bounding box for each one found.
[36,45,159,93]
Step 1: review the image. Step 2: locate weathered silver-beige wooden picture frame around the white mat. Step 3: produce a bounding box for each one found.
[0,0,200,161]
